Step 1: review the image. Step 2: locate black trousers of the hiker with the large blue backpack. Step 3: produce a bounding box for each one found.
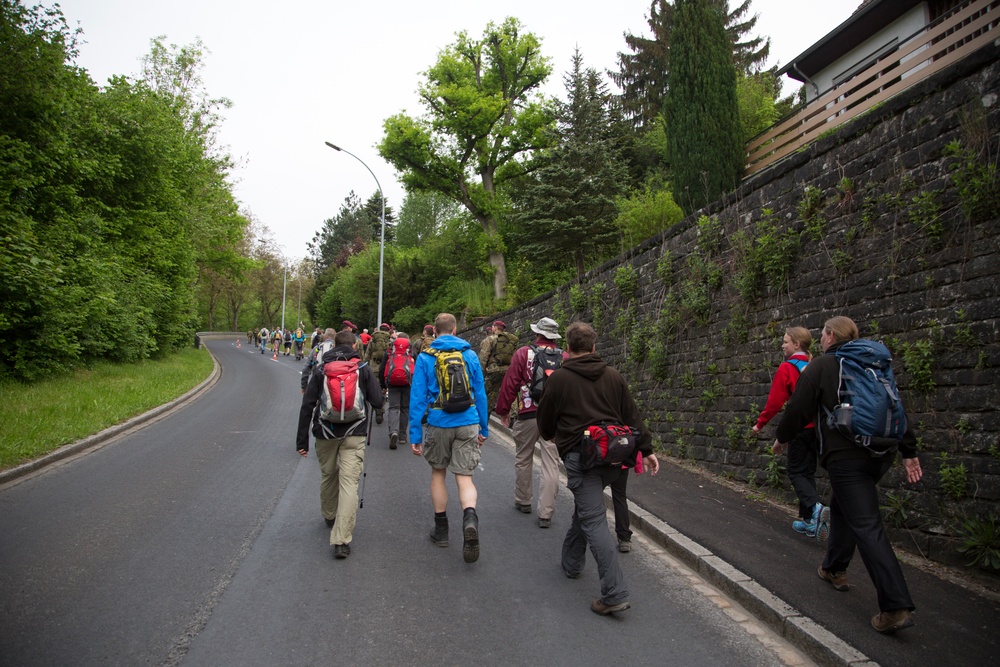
[823,457,914,611]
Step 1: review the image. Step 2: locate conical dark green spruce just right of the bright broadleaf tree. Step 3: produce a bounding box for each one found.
[512,49,627,277]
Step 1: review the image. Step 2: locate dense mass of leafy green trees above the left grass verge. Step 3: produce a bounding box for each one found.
[0,0,246,379]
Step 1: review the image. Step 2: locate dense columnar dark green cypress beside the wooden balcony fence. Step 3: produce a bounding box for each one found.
[664,0,744,213]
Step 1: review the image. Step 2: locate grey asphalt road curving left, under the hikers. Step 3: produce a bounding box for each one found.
[0,341,796,667]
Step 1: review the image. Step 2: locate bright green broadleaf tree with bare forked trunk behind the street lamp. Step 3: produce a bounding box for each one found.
[379,18,552,299]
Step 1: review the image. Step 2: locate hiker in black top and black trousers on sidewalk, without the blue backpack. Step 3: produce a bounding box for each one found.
[775,317,923,633]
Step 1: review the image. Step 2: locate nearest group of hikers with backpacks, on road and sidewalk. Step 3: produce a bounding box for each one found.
[282,313,922,633]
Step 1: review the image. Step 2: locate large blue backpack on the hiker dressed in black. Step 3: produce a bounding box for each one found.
[823,340,906,456]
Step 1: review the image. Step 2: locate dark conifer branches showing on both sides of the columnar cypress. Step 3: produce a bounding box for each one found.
[611,0,768,128]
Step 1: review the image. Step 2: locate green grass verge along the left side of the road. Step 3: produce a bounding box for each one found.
[0,348,212,470]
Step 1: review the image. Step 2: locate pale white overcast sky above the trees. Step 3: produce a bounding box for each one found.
[54,0,860,259]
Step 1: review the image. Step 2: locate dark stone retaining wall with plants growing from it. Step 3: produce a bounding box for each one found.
[459,43,1000,562]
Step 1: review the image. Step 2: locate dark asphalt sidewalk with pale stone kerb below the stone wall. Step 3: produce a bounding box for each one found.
[490,418,1000,667]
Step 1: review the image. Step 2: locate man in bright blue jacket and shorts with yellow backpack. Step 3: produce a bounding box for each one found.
[410,313,490,563]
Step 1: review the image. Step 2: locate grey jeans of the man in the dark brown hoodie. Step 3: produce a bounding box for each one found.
[562,452,628,605]
